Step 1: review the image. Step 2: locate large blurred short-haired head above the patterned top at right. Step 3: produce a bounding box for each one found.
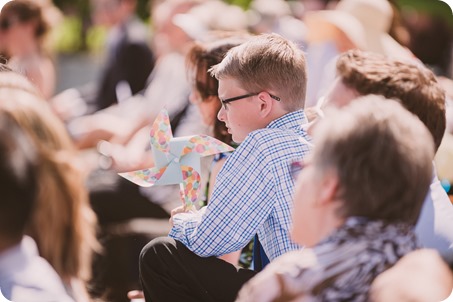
[292,95,434,246]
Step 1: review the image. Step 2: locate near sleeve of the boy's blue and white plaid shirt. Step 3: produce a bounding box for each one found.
[169,133,276,257]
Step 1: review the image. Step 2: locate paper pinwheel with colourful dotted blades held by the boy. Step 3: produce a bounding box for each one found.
[119,109,234,208]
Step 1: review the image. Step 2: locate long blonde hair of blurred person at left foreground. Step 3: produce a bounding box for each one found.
[0,72,99,282]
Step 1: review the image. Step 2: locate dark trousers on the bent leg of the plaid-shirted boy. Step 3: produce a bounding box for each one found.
[140,237,256,302]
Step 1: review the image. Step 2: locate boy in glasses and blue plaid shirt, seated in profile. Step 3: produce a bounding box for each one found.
[140,34,309,301]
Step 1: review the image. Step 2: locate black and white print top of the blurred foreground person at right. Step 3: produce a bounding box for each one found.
[237,217,419,302]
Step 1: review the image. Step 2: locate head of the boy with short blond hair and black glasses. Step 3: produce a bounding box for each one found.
[211,34,307,142]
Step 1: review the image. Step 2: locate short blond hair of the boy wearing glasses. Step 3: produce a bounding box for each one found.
[210,34,307,111]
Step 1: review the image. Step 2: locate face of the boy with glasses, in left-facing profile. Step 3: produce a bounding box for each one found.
[217,78,266,143]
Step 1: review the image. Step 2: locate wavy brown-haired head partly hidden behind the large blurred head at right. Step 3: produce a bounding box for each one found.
[326,50,446,150]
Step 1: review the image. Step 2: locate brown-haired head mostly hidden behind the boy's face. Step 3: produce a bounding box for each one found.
[187,37,251,143]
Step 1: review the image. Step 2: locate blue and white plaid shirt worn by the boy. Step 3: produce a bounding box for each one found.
[169,110,310,260]
